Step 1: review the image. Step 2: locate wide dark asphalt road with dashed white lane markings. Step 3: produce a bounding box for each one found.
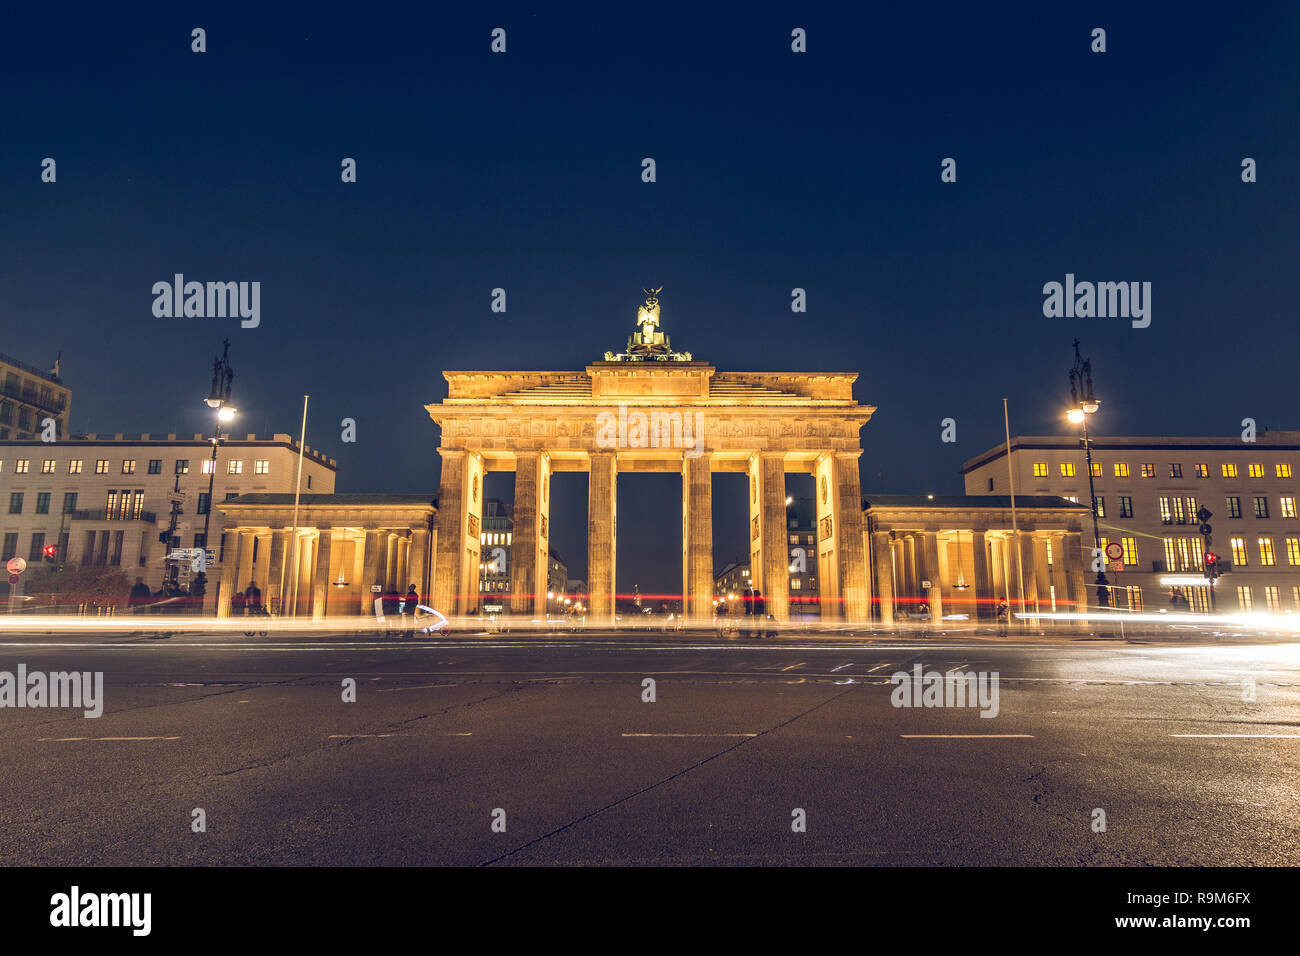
[0,635,1300,865]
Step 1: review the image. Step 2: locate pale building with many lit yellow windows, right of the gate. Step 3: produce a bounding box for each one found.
[962,431,1300,613]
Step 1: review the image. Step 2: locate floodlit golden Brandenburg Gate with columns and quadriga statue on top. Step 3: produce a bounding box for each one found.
[426,289,875,620]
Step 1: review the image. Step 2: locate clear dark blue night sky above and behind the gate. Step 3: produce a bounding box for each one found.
[0,3,1300,591]
